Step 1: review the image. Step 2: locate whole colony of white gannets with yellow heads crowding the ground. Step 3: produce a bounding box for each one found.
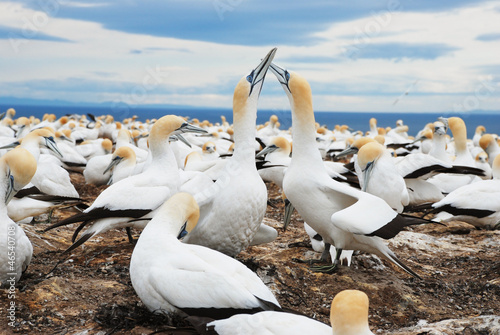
[0,48,500,335]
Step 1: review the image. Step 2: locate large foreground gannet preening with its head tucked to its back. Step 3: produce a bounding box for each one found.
[130,192,280,319]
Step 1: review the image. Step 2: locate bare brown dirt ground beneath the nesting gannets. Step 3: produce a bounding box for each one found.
[0,174,500,335]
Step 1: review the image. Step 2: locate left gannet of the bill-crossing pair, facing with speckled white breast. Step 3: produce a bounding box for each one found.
[184,48,277,256]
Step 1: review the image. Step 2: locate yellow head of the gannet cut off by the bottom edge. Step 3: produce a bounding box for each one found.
[330,290,373,335]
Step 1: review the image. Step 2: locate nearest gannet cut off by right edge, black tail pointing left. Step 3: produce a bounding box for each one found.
[430,156,500,229]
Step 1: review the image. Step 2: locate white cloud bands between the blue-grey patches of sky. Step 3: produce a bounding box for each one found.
[0,2,500,111]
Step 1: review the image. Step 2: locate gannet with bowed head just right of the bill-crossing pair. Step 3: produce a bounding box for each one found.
[358,142,410,213]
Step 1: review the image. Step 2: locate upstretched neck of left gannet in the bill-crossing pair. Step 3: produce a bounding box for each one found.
[233,78,258,164]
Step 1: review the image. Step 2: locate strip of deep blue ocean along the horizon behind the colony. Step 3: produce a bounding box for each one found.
[0,105,500,138]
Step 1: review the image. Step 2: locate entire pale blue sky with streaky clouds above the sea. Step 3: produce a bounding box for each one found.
[0,0,500,112]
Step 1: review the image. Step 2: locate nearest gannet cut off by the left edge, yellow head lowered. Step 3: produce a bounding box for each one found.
[0,148,36,287]
